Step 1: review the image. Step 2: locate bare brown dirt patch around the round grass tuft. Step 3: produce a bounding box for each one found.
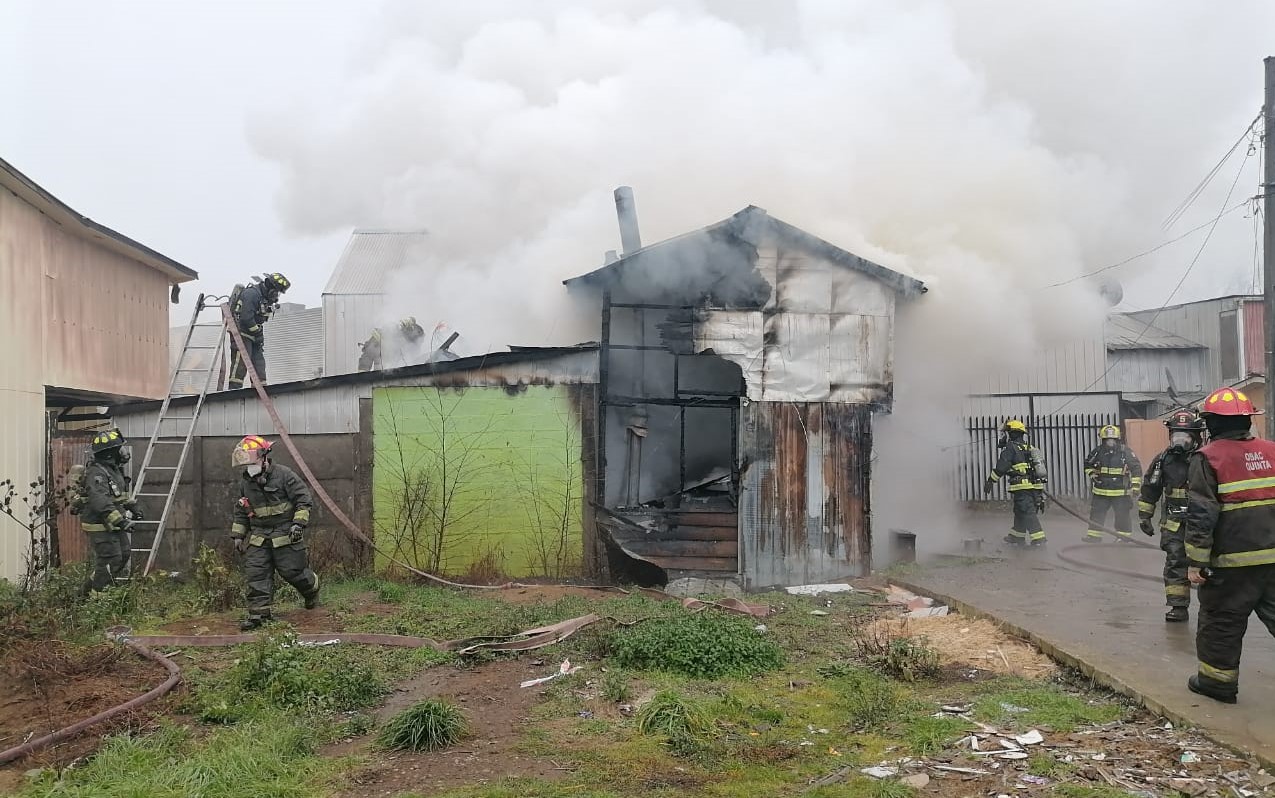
[323,658,561,798]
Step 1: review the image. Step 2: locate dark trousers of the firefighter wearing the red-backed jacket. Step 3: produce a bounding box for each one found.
[1196,565,1275,696]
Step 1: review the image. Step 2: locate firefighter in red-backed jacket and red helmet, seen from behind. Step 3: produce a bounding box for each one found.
[1186,388,1275,704]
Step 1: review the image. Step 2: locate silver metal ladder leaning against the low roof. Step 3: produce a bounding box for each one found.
[133,294,227,576]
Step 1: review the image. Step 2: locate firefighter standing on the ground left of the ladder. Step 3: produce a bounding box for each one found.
[80,430,142,595]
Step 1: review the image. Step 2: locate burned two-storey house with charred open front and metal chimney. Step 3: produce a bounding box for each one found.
[566,189,926,589]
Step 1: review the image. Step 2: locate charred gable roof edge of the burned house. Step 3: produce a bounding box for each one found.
[562,205,928,296]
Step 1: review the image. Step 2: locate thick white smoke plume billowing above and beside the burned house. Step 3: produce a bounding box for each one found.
[250,0,1275,558]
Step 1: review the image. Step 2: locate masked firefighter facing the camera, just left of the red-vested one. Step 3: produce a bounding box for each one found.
[1137,409,1204,623]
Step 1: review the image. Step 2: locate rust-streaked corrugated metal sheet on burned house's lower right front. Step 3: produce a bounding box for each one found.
[740,402,872,589]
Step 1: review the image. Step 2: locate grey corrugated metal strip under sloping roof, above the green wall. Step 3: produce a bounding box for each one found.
[115,352,598,440]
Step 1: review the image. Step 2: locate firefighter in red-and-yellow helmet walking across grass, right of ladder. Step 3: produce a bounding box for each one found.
[231,435,319,631]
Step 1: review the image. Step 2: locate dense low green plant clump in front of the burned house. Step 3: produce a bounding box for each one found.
[611,612,784,679]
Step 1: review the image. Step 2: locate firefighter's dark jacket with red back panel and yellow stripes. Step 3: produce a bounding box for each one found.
[1186,433,1275,569]
